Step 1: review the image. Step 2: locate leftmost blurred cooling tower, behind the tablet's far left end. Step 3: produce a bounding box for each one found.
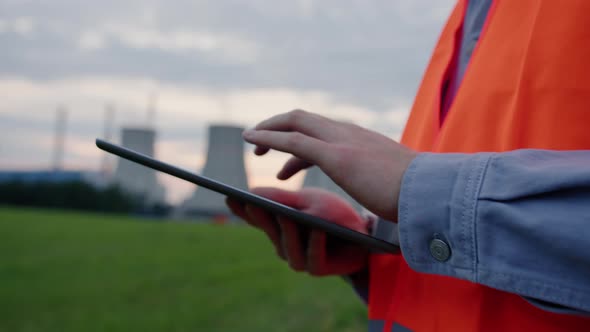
[114,128,165,205]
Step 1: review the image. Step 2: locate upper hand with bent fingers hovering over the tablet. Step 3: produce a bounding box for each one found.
[244,110,417,220]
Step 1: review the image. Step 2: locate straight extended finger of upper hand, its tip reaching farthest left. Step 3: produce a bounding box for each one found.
[244,130,330,165]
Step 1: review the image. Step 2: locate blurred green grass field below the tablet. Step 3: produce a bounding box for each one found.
[0,208,366,332]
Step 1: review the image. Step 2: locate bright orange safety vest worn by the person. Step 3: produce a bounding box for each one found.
[369,0,590,332]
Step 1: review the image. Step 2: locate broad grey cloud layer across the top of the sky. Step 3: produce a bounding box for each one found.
[0,0,452,111]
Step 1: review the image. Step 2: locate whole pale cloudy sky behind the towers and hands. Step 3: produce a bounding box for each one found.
[0,0,454,203]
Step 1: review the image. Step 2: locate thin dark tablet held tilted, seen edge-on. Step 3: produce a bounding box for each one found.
[96,139,399,253]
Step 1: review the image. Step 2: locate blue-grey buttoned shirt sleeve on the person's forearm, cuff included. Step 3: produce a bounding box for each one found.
[399,150,590,315]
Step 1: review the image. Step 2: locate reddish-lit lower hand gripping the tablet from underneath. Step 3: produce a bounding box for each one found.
[227,188,368,276]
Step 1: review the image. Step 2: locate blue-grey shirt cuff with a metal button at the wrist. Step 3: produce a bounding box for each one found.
[398,153,493,282]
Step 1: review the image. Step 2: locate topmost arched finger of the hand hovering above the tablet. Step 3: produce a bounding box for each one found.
[254,110,331,139]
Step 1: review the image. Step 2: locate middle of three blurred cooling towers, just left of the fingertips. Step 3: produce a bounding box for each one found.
[177,125,248,217]
